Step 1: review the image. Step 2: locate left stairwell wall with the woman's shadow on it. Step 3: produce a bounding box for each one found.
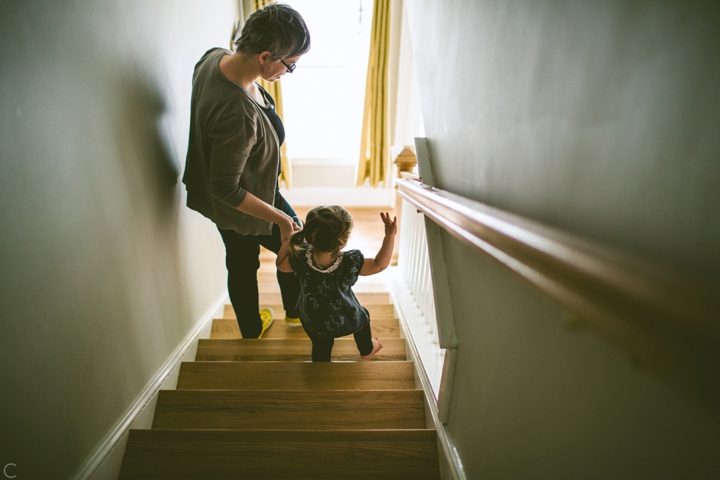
[0,0,237,478]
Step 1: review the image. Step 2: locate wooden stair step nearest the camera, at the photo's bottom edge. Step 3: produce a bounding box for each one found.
[119,429,440,480]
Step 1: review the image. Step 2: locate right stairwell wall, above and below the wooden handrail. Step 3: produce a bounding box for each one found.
[405,0,720,479]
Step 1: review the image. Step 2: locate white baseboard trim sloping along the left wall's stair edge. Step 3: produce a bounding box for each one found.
[73,292,228,480]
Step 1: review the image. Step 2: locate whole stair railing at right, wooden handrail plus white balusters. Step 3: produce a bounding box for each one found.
[397,139,720,410]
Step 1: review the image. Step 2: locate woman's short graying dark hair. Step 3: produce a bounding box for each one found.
[235,3,310,60]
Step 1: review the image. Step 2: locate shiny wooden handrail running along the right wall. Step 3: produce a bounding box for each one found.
[397,178,720,406]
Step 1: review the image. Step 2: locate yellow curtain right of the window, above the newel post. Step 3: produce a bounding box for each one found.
[355,0,390,187]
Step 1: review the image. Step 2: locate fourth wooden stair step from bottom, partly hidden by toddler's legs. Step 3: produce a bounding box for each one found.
[195,338,407,362]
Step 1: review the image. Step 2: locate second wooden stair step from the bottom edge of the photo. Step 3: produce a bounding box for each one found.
[153,390,425,430]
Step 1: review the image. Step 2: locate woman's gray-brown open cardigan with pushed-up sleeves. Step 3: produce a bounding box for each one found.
[183,48,280,235]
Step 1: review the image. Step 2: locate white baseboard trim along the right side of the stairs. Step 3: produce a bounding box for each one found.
[389,267,466,480]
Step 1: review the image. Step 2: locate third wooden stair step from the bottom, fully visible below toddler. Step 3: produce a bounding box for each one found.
[177,361,415,390]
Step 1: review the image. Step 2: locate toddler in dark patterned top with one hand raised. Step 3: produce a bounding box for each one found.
[276,205,397,362]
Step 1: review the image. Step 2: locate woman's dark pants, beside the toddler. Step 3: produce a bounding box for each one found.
[218,192,300,338]
